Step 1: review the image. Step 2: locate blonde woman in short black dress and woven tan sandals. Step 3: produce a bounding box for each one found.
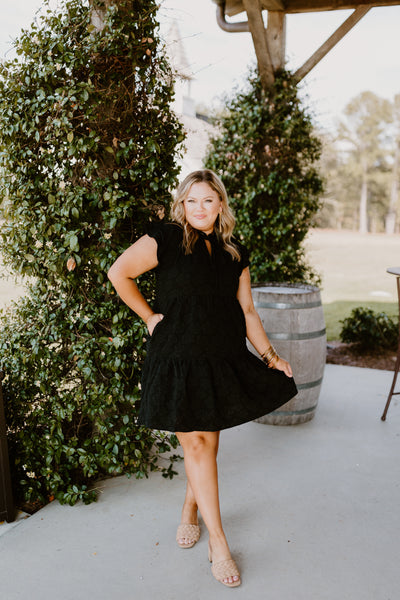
[108,169,297,587]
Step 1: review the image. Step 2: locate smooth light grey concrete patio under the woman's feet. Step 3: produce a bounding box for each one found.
[0,365,400,600]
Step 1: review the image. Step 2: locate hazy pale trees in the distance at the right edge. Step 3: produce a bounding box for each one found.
[316,91,400,234]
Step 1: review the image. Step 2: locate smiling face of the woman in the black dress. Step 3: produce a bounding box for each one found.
[183,181,222,234]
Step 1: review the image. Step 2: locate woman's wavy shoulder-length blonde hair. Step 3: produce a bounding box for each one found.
[171,169,240,260]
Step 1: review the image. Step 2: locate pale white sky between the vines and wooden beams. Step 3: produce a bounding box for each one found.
[0,0,400,129]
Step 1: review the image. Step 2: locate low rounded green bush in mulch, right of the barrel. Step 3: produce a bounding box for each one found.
[340,307,399,353]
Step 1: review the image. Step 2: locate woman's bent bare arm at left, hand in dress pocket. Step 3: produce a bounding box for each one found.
[107,235,163,335]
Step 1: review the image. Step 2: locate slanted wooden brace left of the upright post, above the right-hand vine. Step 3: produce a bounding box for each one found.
[243,0,275,90]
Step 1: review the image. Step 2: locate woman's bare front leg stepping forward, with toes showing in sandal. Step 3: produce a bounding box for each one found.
[176,431,238,583]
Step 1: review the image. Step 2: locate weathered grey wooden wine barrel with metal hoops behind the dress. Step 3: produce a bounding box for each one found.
[252,283,326,425]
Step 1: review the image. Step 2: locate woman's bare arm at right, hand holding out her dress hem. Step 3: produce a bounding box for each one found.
[237,267,292,377]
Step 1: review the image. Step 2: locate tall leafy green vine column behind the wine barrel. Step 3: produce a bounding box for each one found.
[206,72,322,283]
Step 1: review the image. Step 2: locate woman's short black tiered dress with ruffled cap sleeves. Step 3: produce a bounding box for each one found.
[139,223,297,432]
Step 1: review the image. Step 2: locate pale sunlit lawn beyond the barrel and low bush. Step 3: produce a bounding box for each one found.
[305,229,400,340]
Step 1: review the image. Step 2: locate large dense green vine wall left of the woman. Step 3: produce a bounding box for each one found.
[0,0,183,504]
